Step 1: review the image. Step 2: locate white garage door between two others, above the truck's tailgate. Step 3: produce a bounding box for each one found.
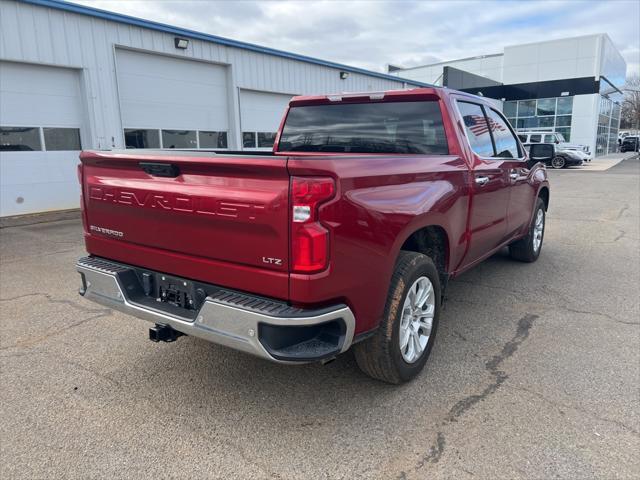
[116,50,229,148]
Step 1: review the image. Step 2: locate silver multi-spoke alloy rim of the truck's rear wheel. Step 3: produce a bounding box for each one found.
[399,277,436,363]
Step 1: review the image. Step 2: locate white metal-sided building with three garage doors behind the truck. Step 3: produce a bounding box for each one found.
[0,0,421,216]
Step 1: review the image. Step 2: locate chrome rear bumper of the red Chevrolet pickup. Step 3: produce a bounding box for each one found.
[76,257,355,363]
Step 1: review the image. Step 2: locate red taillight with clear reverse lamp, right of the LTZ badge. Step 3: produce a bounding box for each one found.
[291,177,335,273]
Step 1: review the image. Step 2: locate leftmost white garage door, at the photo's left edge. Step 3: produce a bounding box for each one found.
[0,62,83,217]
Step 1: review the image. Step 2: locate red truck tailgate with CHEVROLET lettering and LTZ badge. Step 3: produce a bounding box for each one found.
[80,151,289,298]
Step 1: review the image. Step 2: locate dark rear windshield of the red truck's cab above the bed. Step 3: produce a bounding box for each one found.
[278,101,449,155]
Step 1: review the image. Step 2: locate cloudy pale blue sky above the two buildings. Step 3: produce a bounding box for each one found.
[75,0,640,75]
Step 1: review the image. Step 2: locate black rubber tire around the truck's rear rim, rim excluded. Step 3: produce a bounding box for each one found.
[354,251,442,384]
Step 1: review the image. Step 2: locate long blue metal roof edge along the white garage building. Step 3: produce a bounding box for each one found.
[19,0,434,87]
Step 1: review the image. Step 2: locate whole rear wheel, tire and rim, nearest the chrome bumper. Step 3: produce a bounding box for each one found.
[354,251,441,384]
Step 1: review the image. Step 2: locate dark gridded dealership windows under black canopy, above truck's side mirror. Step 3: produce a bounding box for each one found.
[503,97,573,141]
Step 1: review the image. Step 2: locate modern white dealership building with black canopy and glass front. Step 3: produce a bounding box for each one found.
[389,33,627,156]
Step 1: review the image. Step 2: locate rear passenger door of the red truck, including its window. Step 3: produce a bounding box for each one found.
[457,100,510,268]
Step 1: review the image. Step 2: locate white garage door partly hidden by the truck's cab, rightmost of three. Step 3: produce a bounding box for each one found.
[240,90,292,149]
